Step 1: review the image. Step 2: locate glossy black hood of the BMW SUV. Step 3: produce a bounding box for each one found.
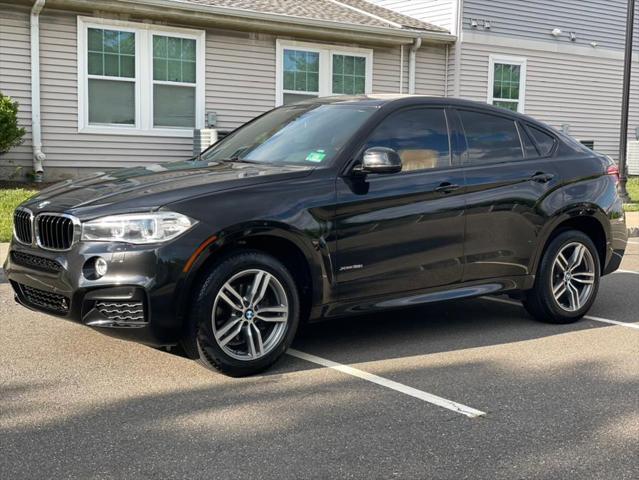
[23,161,313,218]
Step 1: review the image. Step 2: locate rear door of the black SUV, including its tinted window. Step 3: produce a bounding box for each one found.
[458,109,561,281]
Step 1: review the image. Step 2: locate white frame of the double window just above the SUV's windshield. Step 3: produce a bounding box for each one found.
[275,38,373,107]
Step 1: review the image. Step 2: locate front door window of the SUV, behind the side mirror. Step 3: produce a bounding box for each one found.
[366,108,451,172]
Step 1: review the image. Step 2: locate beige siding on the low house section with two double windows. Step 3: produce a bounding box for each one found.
[0,7,445,174]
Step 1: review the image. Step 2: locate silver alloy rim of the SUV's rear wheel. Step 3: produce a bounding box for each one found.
[550,242,596,312]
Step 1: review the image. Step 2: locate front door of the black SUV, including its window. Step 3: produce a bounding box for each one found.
[335,108,464,299]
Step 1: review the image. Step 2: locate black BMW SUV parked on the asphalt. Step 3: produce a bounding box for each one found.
[4,96,626,376]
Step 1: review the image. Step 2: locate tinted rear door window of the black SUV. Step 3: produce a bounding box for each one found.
[459,110,524,165]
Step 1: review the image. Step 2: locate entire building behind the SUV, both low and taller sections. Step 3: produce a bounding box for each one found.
[0,0,639,180]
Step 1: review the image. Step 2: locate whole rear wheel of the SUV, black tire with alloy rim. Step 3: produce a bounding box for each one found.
[523,230,601,324]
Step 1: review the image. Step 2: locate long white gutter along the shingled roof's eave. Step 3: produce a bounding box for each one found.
[50,0,457,44]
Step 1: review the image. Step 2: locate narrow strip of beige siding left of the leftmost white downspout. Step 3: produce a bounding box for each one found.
[0,7,32,171]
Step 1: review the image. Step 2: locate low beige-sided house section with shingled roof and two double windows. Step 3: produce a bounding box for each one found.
[0,0,455,180]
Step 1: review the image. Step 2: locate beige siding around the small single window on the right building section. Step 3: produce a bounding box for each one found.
[461,43,639,158]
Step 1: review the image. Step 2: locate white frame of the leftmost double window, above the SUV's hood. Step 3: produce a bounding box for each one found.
[78,16,206,137]
